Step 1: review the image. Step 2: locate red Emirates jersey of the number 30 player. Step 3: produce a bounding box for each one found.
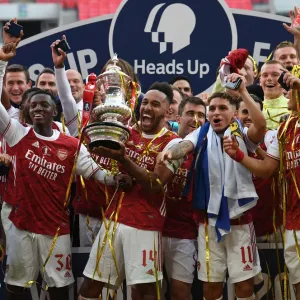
[10,128,86,236]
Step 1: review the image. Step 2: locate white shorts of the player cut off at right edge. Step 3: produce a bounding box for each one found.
[284,230,300,284]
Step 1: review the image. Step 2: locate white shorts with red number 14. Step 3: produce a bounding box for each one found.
[83,220,163,289]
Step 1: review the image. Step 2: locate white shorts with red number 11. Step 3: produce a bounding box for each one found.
[198,223,261,283]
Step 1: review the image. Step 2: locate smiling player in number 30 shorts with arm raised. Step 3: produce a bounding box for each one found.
[0,24,115,299]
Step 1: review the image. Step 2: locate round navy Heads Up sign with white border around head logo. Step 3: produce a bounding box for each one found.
[108,0,238,91]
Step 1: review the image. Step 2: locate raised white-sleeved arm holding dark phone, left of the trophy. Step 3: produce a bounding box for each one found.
[51,36,78,137]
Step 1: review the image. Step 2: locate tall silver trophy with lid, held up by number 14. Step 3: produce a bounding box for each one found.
[83,55,140,150]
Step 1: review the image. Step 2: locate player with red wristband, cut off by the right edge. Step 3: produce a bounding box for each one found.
[223,73,300,300]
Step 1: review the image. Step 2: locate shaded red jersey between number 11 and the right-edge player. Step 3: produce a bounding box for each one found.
[249,134,283,237]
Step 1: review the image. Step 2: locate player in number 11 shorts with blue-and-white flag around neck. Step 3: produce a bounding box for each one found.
[158,74,266,300]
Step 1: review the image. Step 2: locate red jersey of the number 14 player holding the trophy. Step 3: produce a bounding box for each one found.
[105,129,178,231]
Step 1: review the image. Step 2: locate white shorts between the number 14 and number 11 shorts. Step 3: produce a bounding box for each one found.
[163,237,197,283]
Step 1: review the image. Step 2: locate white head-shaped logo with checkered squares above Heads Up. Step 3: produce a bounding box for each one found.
[144,3,196,54]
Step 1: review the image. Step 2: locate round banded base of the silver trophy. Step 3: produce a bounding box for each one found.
[82,122,130,150]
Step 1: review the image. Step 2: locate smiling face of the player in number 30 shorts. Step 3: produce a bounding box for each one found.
[28,94,55,127]
